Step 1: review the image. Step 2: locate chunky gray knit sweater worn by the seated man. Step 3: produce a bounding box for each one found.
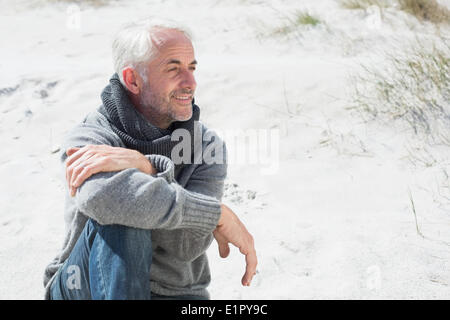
[44,89,227,299]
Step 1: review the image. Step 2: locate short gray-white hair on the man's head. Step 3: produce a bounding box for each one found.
[112,18,192,86]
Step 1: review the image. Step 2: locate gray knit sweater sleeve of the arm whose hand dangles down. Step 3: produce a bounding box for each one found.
[61,124,220,234]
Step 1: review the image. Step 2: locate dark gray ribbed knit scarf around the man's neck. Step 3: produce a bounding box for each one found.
[99,73,200,166]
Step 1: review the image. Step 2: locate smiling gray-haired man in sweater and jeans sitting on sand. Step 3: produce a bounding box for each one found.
[44,22,257,299]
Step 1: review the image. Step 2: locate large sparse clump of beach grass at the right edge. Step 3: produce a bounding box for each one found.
[354,39,450,147]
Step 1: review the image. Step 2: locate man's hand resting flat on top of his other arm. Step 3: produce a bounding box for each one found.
[66,145,156,197]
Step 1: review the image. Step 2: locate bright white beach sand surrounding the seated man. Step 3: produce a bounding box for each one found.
[0,0,450,299]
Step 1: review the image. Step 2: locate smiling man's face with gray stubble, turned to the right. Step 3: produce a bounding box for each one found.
[140,30,197,126]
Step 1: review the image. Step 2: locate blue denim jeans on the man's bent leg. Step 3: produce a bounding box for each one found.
[50,219,207,300]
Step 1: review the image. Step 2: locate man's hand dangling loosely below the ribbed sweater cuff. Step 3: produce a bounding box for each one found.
[213,204,258,286]
